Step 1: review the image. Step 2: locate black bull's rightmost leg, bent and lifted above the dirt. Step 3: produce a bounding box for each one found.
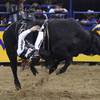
[56,57,72,75]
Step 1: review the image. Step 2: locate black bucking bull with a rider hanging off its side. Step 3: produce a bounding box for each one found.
[3,18,100,89]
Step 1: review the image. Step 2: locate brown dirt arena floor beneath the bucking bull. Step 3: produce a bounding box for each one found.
[0,64,100,100]
